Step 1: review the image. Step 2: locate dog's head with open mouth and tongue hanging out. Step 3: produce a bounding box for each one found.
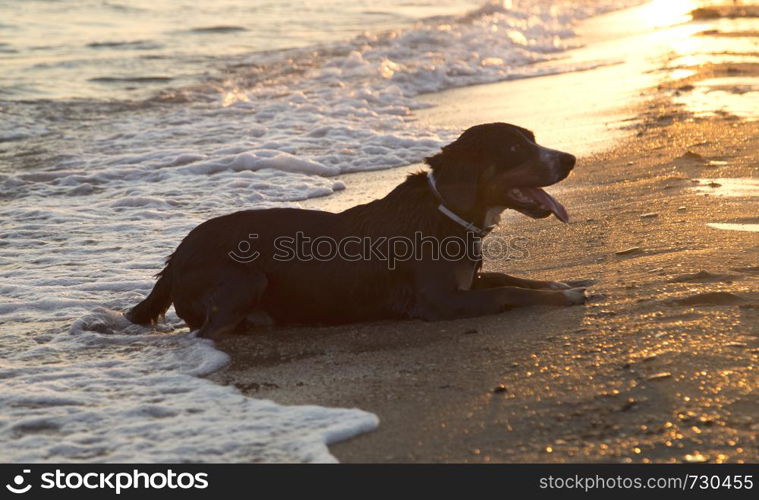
[426,123,575,222]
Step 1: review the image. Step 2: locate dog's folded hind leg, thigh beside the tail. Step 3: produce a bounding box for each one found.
[198,265,267,338]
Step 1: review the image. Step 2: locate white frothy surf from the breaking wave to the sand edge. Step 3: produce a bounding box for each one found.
[0,0,633,462]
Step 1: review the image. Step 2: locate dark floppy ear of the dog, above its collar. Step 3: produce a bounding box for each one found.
[427,153,478,213]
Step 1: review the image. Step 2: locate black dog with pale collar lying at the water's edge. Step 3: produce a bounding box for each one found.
[125,123,586,338]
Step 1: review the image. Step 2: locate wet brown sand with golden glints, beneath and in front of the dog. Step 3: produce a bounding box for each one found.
[211,1,759,462]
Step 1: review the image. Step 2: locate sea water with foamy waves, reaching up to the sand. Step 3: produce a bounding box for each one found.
[0,0,648,462]
